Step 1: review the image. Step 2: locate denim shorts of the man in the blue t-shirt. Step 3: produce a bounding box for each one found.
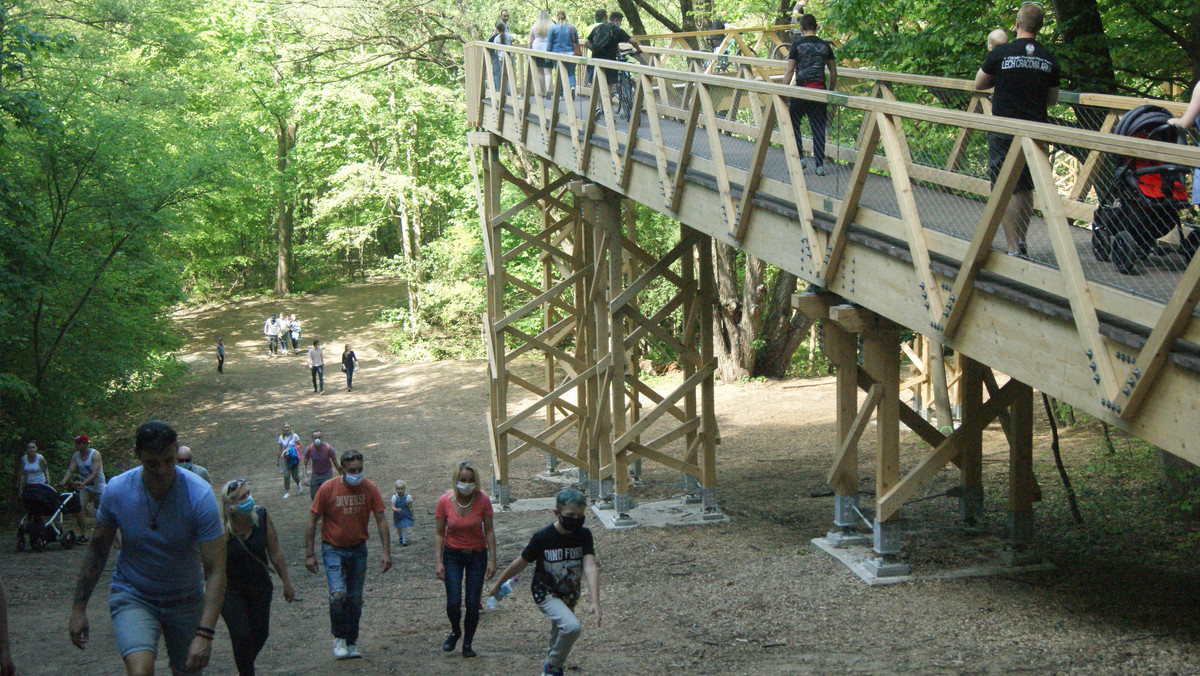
[108,590,204,671]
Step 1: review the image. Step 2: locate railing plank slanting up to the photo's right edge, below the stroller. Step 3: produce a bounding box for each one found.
[1114,248,1200,420]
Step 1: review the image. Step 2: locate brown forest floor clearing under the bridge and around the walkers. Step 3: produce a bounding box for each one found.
[0,277,1200,676]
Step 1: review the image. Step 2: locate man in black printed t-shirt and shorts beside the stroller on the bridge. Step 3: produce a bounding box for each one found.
[974,2,1061,256]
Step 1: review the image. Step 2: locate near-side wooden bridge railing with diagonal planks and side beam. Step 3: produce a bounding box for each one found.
[467,43,1200,470]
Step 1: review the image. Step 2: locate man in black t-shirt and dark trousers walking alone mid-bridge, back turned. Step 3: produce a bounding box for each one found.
[782,14,838,177]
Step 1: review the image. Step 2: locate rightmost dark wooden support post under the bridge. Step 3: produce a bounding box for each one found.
[1008,381,1037,564]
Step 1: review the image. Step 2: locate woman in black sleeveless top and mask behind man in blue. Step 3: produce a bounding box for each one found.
[221,479,296,676]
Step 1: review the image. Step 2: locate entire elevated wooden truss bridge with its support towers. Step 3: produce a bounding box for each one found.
[466,28,1200,570]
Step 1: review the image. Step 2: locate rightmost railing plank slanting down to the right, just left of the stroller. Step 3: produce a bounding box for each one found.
[1021,138,1117,401]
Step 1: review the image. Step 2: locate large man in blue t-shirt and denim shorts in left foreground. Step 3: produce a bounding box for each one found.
[71,420,226,674]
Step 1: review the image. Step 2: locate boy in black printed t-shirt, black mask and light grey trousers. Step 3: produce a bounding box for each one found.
[491,489,602,676]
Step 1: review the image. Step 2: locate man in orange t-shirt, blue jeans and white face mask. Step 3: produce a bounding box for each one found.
[304,450,391,659]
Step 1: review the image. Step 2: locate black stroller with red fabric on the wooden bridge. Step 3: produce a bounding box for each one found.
[1092,106,1200,275]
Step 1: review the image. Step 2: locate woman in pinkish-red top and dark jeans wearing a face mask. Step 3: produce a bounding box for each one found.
[433,461,496,657]
